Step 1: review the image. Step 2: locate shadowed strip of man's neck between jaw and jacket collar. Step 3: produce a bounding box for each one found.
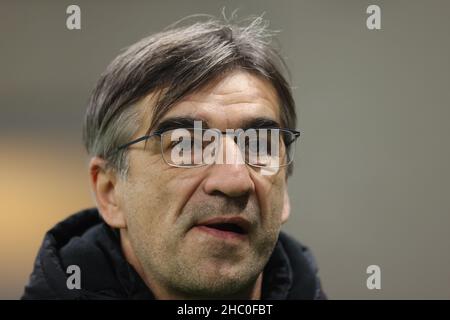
[120,229,263,300]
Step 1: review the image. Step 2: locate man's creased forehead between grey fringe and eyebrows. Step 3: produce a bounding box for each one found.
[142,70,281,129]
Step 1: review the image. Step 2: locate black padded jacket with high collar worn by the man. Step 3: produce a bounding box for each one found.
[22,208,325,299]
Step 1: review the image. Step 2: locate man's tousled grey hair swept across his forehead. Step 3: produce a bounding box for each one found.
[83,17,296,177]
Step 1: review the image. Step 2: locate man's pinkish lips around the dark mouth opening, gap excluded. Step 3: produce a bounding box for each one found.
[194,216,250,240]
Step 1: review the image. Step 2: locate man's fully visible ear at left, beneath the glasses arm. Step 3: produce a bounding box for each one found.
[89,157,126,228]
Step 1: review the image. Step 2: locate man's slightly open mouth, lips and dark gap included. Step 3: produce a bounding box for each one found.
[195,217,250,240]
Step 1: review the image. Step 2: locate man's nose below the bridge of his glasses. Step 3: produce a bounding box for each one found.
[204,133,255,197]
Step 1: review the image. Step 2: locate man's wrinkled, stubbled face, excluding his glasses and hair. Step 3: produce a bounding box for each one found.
[117,71,286,297]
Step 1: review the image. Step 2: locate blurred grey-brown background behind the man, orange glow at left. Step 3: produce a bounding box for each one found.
[0,0,450,299]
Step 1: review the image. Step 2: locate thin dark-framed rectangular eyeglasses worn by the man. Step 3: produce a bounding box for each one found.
[116,128,300,168]
